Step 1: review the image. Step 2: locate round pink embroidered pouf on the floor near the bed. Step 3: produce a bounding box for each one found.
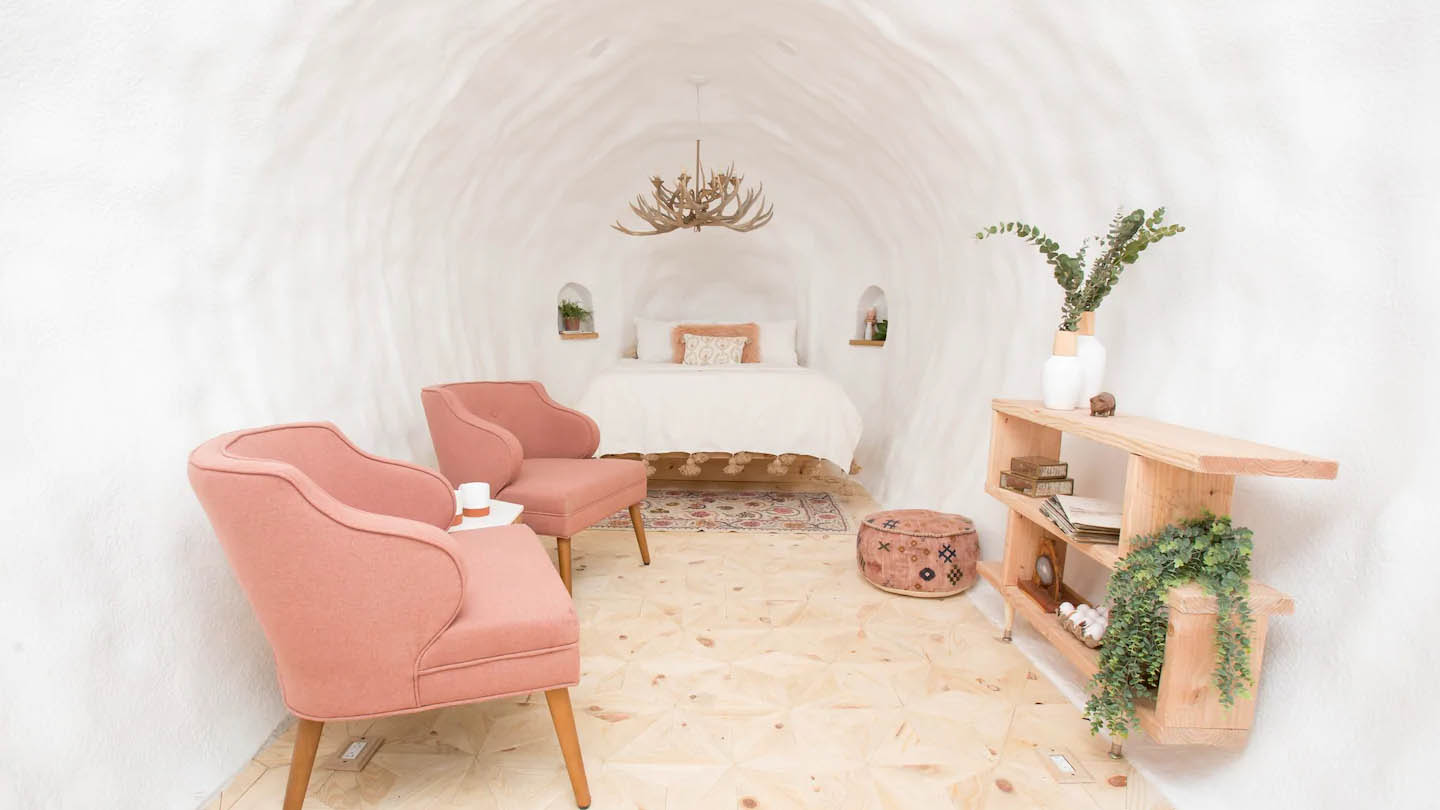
[855,509,981,597]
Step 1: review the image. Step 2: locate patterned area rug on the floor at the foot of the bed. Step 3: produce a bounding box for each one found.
[592,490,851,535]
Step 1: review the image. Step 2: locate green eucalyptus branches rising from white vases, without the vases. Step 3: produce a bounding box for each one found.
[975,208,1185,331]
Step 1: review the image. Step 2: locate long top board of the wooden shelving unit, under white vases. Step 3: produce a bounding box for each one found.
[991,399,1339,479]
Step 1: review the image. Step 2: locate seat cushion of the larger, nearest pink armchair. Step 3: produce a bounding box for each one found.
[420,526,580,671]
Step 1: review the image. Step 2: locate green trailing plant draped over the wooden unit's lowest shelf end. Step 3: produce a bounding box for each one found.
[1086,513,1254,738]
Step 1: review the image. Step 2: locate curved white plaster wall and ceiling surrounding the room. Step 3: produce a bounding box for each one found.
[0,0,1440,810]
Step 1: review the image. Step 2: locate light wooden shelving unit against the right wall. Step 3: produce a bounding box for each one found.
[979,399,1339,747]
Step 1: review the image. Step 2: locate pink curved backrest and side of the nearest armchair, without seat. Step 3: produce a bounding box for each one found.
[189,422,465,719]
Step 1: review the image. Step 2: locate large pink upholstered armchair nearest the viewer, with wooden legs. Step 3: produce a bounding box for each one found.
[189,422,590,810]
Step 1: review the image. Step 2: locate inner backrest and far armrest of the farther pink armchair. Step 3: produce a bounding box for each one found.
[441,380,600,458]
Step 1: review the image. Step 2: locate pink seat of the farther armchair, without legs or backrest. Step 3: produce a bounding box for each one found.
[495,458,645,538]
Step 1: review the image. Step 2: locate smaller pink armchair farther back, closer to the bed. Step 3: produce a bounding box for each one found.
[420,380,649,589]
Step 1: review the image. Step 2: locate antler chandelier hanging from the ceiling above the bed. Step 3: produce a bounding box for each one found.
[611,84,775,236]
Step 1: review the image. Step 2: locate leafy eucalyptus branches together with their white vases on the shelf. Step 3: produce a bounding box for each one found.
[975,208,1185,409]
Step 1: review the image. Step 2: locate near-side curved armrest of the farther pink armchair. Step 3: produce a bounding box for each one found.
[420,385,524,484]
